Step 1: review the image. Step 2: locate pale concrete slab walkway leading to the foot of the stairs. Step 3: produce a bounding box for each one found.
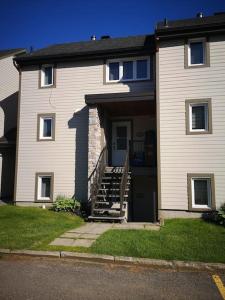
[50,223,160,247]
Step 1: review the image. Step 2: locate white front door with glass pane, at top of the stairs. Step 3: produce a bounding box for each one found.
[112,121,131,167]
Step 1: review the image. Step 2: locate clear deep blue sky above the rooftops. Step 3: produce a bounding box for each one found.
[0,0,225,49]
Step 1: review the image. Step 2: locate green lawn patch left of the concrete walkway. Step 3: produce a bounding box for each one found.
[0,205,83,249]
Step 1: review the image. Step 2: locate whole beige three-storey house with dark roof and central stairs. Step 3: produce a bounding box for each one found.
[14,14,225,221]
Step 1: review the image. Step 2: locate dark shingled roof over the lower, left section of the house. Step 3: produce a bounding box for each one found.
[15,35,154,63]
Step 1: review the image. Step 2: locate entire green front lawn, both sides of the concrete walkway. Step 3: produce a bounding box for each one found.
[0,206,225,263]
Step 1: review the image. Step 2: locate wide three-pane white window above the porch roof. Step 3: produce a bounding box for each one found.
[106,57,150,82]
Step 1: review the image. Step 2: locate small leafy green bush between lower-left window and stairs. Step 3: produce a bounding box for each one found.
[53,195,80,212]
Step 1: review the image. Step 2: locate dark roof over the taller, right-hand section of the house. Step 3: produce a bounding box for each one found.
[156,13,225,35]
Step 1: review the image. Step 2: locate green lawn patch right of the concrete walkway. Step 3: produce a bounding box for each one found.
[91,219,225,263]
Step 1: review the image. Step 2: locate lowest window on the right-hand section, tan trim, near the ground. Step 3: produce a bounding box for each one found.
[188,174,215,210]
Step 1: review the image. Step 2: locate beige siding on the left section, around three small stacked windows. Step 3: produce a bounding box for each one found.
[16,60,153,202]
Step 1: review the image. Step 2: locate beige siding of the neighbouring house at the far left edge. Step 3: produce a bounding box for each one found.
[0,56,19,137]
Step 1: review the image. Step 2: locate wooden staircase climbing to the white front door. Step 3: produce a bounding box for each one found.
[88,149,131,221]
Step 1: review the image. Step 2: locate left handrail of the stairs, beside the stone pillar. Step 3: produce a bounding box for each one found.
[88,146,107,216]
